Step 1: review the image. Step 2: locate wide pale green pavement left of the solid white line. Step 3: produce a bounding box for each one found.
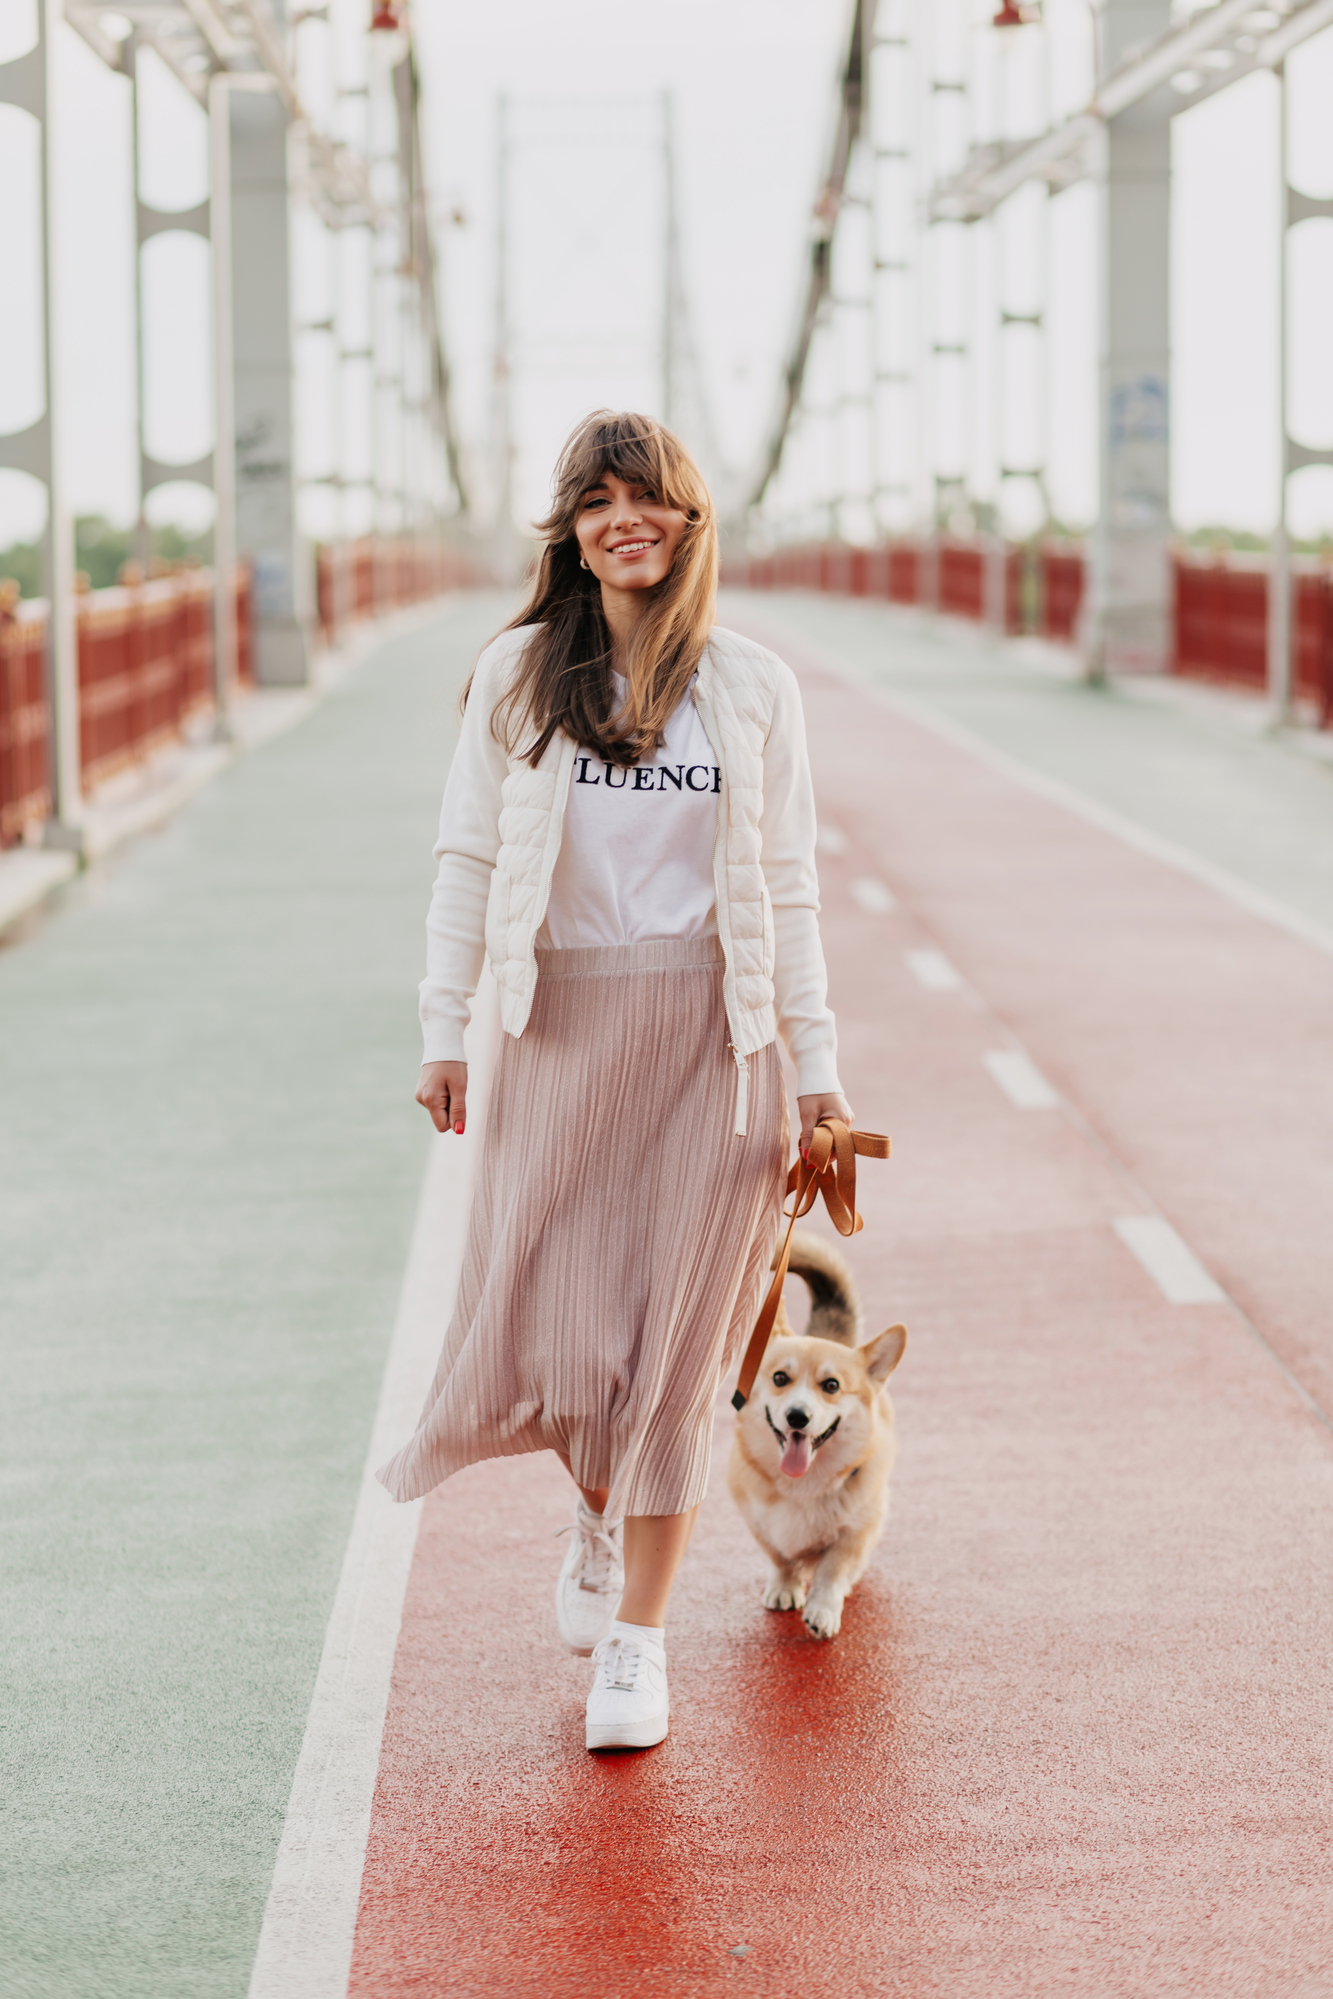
[0,596,508,1999]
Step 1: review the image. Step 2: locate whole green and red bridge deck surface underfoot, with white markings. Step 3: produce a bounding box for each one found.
[0,590,1333,1999]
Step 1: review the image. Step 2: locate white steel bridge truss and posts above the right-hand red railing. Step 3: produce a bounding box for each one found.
[747,0,1333,720]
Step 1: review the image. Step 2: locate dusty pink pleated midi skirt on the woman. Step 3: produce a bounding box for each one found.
[378,938,787,1517]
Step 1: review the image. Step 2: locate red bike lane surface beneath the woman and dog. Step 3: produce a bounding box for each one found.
[350,631,1333,1999]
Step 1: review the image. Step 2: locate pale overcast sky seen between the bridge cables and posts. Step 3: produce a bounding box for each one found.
[0,0,1333,546]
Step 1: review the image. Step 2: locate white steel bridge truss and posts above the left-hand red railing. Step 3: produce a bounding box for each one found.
[0,0,470,846]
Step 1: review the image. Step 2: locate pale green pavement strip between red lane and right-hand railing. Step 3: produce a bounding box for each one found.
[719,592,1333,930]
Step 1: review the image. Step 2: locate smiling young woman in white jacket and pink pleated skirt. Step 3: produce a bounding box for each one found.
[380,412,851,1749]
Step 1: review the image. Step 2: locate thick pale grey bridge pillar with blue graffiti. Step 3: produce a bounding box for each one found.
[1085,0,1171,680]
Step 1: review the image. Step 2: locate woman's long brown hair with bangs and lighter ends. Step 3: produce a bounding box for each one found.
[481,410,717,766]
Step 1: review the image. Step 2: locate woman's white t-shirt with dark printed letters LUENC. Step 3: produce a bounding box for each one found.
[538,674,721,952]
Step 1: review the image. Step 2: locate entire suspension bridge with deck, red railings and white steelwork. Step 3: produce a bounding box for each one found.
[0,0,1333,1999]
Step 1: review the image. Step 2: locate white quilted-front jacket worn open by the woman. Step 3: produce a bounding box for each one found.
[422,626,839,1133]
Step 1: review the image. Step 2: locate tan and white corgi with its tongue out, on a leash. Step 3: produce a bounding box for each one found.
[727,1233,907,1637]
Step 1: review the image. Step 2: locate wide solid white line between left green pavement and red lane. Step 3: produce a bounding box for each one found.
[250,978,496,1999]
